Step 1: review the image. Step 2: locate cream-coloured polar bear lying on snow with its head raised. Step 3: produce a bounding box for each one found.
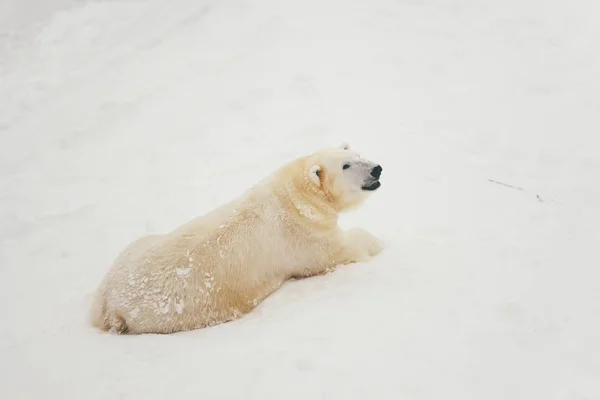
[91,145,383,334]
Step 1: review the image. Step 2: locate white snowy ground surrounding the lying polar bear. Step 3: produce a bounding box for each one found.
[0,0,600,400]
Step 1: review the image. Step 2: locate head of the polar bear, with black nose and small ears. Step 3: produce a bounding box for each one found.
[305,144,382,211]
